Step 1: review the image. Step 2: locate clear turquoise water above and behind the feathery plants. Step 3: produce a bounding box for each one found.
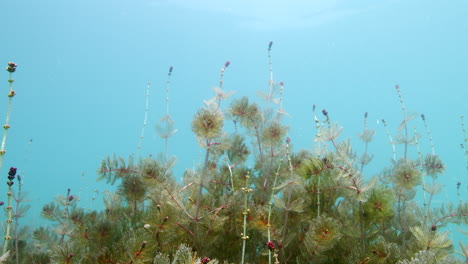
[0,0,468,262]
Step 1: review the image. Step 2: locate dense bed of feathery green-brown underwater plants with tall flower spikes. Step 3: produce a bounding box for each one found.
[0,42,468,264]
